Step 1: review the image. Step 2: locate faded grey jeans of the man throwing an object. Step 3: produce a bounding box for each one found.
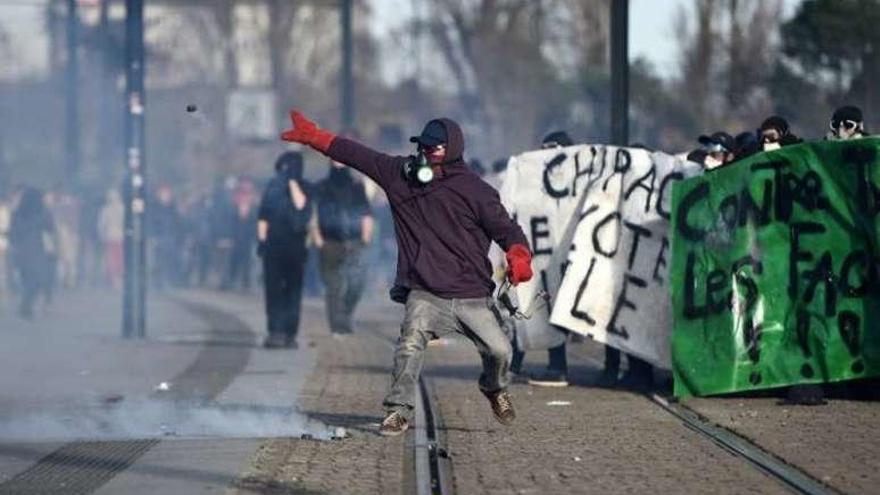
[383,290,512,419]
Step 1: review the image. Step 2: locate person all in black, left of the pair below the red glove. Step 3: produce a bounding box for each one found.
[257,151,311,349]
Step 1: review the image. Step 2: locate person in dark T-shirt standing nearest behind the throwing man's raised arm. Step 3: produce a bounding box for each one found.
[312,162,373,336]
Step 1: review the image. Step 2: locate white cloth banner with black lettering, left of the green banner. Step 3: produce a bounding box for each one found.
[501,145,700,368]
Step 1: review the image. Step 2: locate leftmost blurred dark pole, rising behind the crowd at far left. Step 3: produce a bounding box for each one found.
[64,0,80,184]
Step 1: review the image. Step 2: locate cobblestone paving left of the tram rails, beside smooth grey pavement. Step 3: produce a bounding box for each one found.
[230,298,414,495]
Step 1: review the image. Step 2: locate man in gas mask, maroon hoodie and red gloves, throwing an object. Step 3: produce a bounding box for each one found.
[281,111,532,436]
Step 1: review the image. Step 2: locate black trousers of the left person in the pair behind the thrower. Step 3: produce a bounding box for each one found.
[263,246,306,340]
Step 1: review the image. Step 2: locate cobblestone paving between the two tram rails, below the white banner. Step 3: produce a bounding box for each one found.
[428,340,784,494]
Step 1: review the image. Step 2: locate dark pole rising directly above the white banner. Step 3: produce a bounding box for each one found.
[611,0,629,146]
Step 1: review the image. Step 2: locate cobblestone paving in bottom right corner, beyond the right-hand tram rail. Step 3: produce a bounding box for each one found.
[685,398,880,494]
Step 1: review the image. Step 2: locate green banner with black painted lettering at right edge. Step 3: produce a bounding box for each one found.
[670,138,880,397]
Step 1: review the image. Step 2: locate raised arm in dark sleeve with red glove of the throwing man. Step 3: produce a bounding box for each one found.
[281,110,404,188]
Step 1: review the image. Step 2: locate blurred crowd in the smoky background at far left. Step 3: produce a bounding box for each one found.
[0,177,292,319]
